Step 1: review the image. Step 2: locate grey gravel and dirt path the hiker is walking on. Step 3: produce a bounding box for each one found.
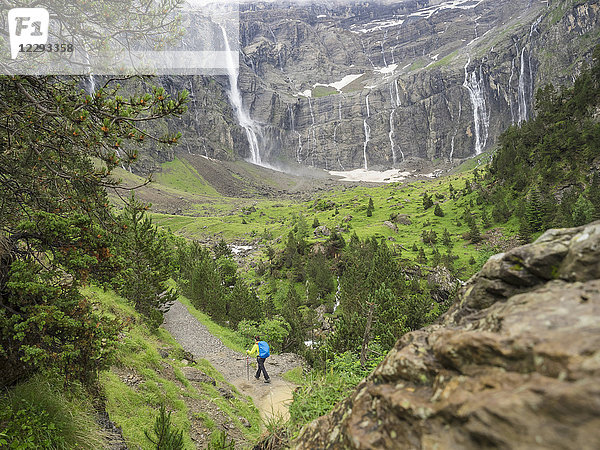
[163,302,301,420]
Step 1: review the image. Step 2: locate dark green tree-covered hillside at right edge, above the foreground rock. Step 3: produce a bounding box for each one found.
[482,47,600,240]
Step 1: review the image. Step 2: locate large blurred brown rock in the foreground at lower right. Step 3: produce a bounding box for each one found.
[295,222,600,449]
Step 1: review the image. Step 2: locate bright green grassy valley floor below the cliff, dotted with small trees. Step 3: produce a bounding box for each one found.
[154,155,518,278]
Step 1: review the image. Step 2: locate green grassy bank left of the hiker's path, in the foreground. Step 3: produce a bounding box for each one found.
[84,288,260,448]
